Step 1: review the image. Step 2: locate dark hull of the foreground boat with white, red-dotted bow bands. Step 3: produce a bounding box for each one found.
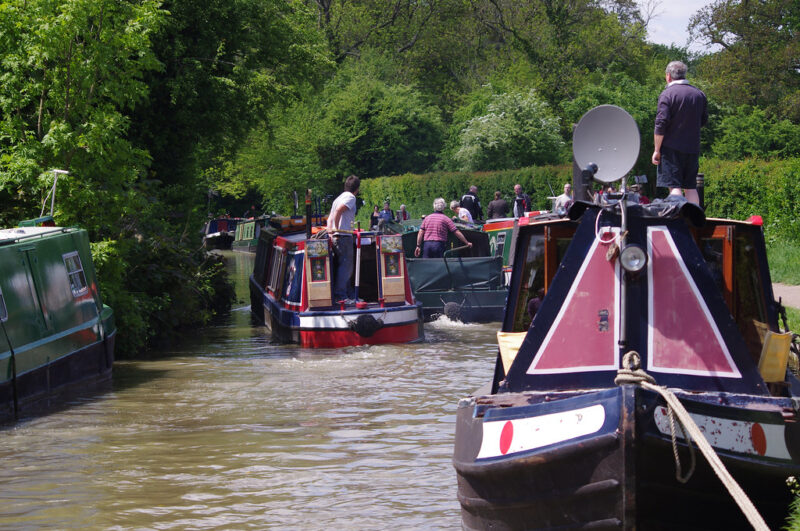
[454,386,800,529]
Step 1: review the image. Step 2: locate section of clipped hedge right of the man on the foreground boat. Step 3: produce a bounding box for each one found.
[700,158,800,243]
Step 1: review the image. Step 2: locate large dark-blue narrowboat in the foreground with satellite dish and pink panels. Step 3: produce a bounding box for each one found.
[453,106,800,529]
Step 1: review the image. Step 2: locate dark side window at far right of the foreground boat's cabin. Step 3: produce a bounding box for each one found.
[733,230,769,360]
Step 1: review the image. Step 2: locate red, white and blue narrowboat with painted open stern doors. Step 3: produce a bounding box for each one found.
[250,221,424,348]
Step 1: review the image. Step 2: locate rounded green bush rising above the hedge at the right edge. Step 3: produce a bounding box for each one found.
[711,105,800,160]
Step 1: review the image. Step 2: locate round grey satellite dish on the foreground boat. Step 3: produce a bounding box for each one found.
[572,105,639,183]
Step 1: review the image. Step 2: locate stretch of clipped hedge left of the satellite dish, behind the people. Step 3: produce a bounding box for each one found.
[357,166,572,226]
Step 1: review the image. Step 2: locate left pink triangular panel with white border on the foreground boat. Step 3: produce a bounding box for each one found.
[528,240,619,374]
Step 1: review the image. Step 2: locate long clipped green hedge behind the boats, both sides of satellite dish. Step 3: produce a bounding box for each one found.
[357,158,800,243]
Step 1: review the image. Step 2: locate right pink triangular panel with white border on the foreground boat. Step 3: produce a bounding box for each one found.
[648,227,741,378]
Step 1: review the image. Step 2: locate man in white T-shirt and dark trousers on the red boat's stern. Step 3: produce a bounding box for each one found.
[327,175,361,301]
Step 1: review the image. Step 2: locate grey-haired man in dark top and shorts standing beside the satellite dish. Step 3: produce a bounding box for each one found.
[652,61,708,204]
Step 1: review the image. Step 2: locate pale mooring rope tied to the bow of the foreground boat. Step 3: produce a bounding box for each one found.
[614,351,769,531]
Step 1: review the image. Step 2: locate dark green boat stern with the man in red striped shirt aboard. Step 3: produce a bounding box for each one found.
[403,223,508,323]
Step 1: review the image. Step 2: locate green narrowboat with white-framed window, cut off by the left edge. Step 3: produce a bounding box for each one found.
[0,216,116,421]
